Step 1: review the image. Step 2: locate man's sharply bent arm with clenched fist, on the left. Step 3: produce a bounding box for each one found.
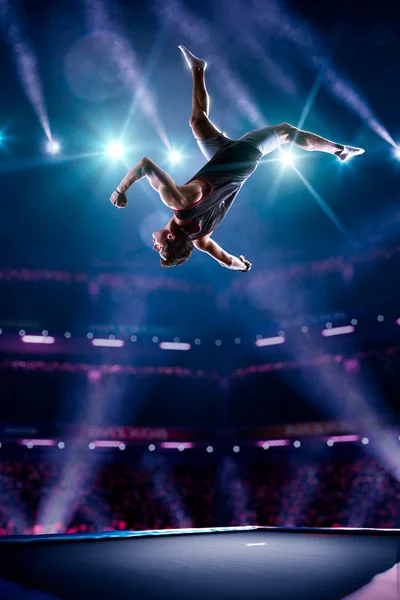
[110,157,182,209]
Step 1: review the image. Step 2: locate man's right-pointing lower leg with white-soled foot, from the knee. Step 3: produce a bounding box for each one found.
[274,123,364,162]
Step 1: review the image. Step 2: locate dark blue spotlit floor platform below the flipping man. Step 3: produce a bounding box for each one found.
[0,527,400,600]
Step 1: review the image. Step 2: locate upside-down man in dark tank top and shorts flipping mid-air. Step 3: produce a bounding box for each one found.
[110,46,364,273]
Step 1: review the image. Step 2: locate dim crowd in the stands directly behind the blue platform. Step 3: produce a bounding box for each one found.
[0,453,400,535]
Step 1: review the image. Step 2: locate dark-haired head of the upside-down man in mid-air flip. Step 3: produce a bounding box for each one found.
[153,228,193,267]
